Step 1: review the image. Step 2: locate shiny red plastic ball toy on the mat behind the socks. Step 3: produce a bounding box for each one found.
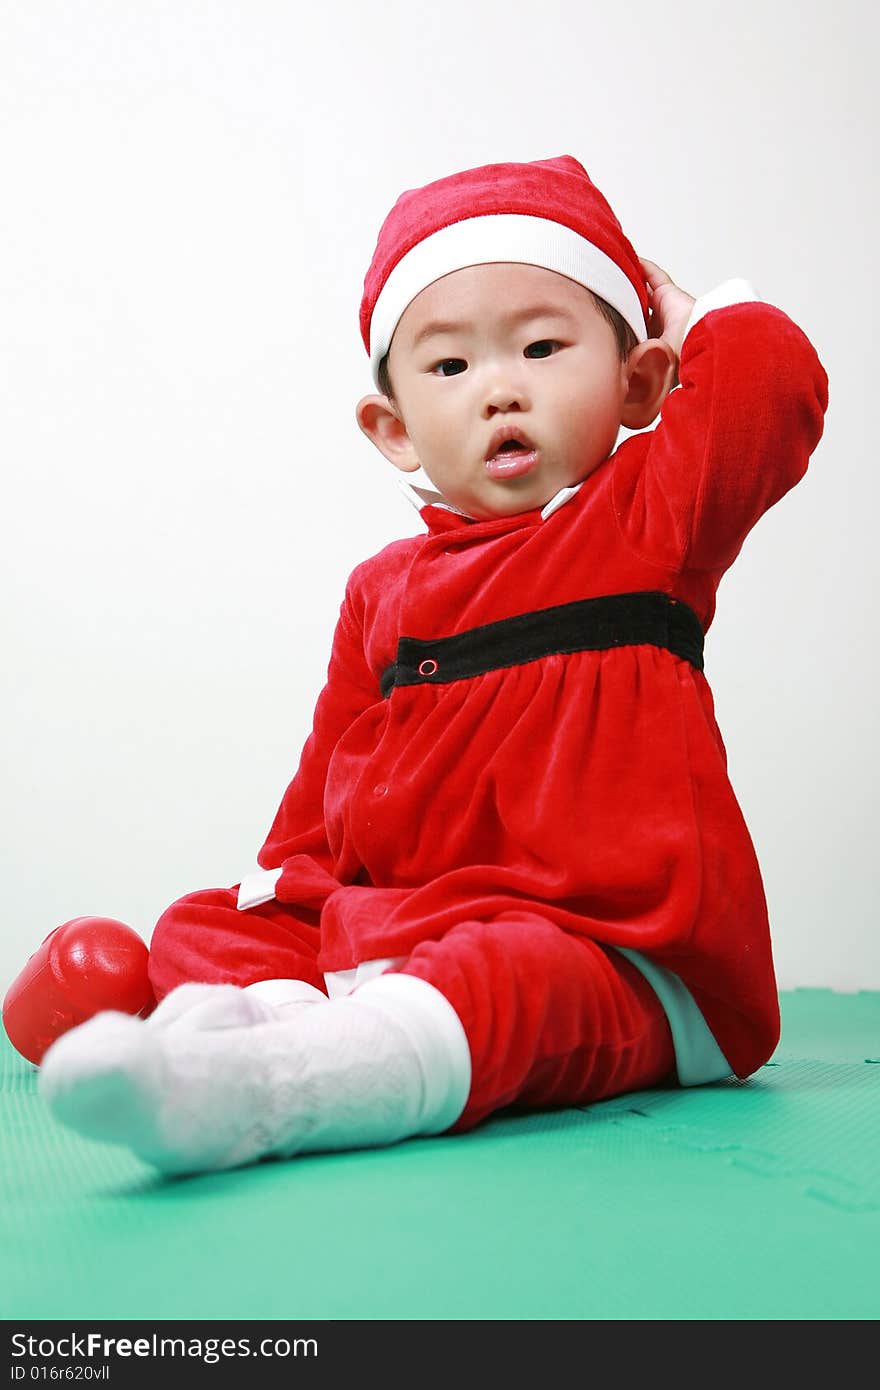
[3,917,156,1066]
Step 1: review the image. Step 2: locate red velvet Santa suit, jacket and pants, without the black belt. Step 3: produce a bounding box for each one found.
[152,293,827,1127]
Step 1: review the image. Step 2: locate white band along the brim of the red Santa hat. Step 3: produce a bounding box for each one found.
[370,213,648,386]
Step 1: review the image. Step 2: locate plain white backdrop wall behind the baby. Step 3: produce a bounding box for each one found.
[0,0,880,990]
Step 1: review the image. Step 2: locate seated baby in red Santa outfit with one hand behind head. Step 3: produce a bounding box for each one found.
[30,156,827,1173]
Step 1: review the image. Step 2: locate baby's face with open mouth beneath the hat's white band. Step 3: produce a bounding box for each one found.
[388,263,627,518]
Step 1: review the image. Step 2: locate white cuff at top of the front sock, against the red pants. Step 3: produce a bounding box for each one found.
[350,974,471,1134]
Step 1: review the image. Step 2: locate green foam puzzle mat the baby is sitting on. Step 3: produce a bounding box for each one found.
[0,990,880,1321]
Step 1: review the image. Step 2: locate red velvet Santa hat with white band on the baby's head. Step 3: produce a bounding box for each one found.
[360,154,648,385]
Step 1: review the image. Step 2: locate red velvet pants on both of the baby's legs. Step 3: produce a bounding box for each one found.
[150,888,674,1130]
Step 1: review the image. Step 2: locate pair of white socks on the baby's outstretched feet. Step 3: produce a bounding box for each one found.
[38,974,470,1173]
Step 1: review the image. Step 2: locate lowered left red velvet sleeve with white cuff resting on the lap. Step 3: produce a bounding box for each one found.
[238,575,381,908]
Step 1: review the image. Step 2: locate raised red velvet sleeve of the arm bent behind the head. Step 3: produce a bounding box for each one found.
[616,281,829,574]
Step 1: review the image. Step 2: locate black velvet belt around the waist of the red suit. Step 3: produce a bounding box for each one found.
[381,589,703,699]
